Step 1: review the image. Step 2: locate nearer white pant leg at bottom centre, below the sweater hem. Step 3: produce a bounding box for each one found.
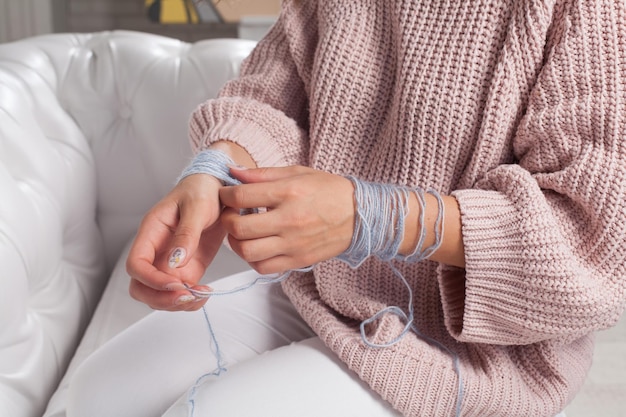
[163,337,401,417]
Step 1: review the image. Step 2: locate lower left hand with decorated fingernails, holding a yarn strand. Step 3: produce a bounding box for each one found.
[126,174,225,311]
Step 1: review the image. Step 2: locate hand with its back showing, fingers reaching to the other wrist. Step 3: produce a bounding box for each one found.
[220,166,355,274]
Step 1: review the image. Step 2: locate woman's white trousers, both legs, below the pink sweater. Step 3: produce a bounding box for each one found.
[67,271,400,417]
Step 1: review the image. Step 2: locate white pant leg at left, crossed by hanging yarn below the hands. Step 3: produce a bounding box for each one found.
[67,271,314,417]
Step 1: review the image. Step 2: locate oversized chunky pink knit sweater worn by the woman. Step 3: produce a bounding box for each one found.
[186,0,626,417]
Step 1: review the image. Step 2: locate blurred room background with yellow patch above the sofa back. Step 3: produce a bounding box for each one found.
[0,0,280,42]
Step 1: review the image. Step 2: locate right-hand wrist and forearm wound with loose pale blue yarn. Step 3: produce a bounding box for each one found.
[337,177,465,267]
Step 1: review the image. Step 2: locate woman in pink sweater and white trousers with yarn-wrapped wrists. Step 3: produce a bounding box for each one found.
[70,0,626,416]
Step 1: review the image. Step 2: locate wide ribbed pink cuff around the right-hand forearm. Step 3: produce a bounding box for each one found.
[440,190,529,345]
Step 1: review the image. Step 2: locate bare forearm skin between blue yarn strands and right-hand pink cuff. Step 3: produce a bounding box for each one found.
[399,193,465,268]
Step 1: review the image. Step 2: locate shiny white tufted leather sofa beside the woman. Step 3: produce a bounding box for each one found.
[0,31,254,417]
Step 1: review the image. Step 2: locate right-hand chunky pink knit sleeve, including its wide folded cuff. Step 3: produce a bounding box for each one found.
[442,1,626,345]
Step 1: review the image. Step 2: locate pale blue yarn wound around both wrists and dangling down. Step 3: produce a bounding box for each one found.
[173,150,463,417]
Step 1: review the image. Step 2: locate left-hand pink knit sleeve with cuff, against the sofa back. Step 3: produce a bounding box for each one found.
[185,1,315,166]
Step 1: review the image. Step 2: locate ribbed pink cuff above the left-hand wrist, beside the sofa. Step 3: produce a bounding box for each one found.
[190,98,308,167]
